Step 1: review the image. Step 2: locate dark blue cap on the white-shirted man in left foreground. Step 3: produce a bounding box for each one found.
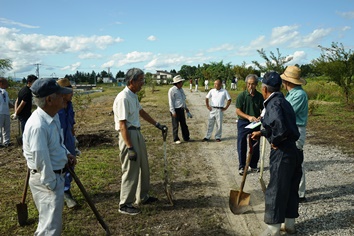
[30,78,73,98]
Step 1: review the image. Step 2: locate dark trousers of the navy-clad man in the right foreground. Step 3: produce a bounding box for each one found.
[264,141,303,224]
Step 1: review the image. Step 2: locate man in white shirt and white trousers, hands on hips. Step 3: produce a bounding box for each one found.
[202,79,231,142]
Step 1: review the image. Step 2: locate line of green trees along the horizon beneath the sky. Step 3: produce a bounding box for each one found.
[0,42,354,103]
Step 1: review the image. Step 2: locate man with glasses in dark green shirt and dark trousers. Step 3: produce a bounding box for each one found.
[236,74,264,175]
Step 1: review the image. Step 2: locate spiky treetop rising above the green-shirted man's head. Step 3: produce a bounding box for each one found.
[252,48,293,73]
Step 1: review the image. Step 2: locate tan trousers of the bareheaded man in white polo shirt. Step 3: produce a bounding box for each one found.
[118,130,150,206]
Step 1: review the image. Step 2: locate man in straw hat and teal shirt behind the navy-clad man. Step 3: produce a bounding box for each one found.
[280,66,308,232]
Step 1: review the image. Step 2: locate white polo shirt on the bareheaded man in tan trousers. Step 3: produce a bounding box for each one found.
[113,87,143,130]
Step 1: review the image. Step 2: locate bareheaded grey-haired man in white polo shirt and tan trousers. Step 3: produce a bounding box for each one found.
[113,68,167,215]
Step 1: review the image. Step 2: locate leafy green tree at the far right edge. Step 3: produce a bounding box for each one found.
[313,42,354,104]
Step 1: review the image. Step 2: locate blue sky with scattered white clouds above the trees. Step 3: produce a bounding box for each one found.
[0,0,354,78]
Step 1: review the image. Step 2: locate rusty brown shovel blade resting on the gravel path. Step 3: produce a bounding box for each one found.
[229,190,251,215]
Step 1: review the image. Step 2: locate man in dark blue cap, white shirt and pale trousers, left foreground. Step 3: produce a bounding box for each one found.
[23,79,76,236]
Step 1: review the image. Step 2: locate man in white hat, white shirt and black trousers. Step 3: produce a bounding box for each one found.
[168,75,190,144]
